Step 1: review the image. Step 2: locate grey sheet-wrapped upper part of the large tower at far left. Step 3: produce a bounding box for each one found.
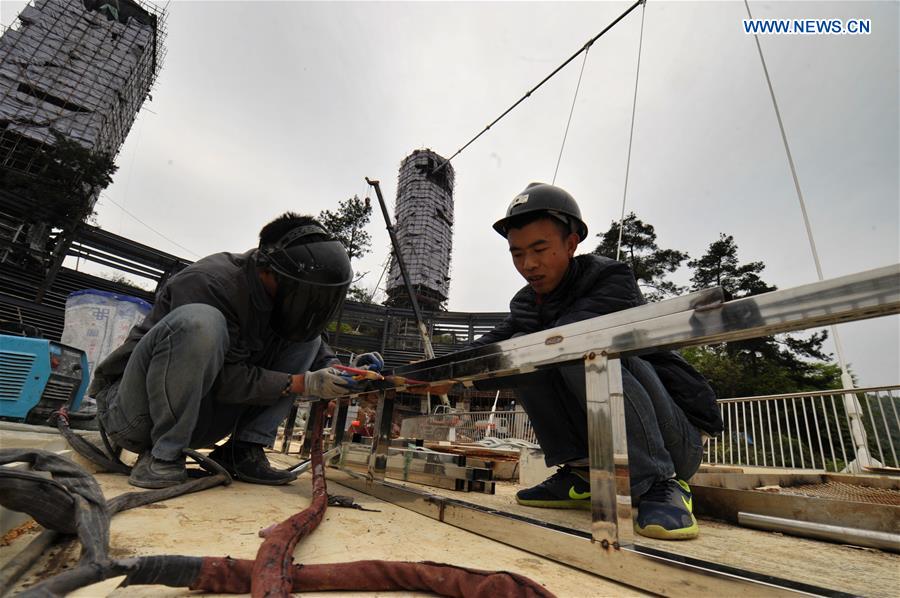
[0,0,165,173]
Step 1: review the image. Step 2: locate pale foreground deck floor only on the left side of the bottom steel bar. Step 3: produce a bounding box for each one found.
[0,474,641,598]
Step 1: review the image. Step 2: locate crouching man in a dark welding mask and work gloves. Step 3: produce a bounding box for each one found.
[89,212,384,488]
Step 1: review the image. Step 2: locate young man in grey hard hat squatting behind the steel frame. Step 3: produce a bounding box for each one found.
[474,183,722,539]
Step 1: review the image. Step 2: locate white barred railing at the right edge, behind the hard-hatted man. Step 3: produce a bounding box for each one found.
[706,385,900,472]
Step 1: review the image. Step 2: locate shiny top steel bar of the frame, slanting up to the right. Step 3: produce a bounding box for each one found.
[394,264,900,383]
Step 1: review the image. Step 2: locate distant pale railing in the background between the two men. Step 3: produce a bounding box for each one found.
[400,411,537,444]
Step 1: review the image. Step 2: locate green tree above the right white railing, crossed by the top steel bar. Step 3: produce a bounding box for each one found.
[684,234,841,397]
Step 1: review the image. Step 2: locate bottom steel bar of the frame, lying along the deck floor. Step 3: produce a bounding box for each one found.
[329,470,847,596]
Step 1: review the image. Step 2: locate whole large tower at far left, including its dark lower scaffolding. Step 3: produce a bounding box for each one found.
[0,0,165,264]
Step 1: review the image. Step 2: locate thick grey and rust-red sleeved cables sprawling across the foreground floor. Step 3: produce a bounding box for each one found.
[0,440,553,598]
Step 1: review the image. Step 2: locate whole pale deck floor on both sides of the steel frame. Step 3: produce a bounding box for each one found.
[0,431,900,597]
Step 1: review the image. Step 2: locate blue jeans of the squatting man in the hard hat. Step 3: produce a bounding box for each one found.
[516,357,703,499]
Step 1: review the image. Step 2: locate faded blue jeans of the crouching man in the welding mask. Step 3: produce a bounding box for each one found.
[97,303,321,460]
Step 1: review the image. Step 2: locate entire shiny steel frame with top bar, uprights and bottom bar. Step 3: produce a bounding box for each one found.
[331,264,900,596]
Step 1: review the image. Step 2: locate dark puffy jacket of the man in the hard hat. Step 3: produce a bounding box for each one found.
[470,254,723,434]
